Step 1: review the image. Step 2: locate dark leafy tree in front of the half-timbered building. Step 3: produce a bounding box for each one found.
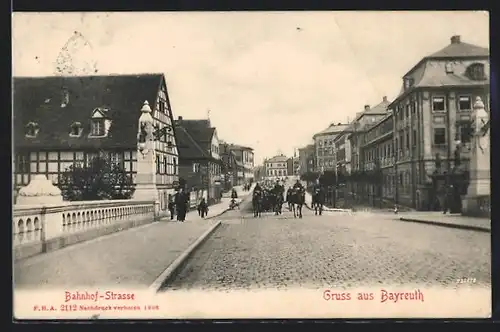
[59,156,135,201]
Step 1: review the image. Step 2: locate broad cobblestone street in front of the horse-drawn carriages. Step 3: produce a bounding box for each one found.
[163,201,491,290]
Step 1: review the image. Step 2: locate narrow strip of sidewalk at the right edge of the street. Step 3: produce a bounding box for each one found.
[398,212,491,232]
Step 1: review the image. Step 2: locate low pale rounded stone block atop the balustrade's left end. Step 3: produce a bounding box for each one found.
[16,174,64,206]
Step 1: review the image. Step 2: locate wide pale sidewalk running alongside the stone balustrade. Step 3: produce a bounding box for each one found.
[14,185,252,290]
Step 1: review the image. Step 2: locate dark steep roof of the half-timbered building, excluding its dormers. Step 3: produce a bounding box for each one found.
[13,74,164,149]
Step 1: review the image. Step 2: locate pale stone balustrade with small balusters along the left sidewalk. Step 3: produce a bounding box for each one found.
[12,200,155,259]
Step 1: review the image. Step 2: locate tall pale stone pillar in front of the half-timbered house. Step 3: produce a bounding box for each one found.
[132,100,160,217]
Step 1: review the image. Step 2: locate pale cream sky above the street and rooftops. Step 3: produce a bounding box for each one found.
[12,11,489,164]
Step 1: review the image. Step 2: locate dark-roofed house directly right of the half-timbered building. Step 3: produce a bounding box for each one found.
[175,117,223,204]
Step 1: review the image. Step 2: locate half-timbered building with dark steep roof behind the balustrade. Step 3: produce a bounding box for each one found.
[13,74,179,213]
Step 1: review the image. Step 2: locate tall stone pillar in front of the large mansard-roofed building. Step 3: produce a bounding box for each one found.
[462,97,491,215]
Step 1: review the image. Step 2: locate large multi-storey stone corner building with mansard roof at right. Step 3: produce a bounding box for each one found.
[390,36,490,210]
